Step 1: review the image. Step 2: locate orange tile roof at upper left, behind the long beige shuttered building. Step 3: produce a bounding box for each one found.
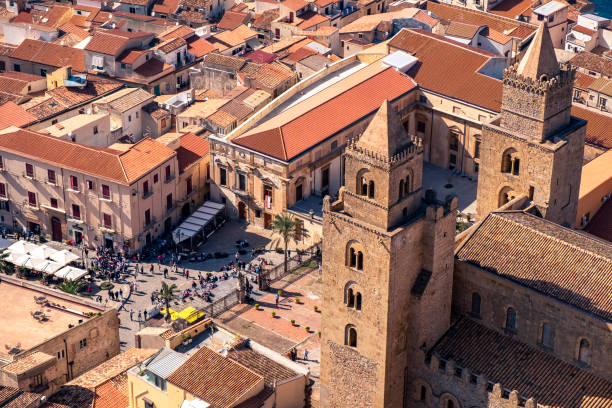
[10,39,85,72]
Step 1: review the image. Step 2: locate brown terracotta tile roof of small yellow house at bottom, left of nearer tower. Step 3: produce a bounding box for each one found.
[167,346,263,408]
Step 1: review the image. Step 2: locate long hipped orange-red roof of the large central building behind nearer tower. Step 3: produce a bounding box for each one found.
[232,67,417,161]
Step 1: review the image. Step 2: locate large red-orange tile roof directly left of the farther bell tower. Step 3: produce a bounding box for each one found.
[389,29,502,112]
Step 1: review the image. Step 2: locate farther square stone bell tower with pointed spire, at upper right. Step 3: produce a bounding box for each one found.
[477,22,586,226]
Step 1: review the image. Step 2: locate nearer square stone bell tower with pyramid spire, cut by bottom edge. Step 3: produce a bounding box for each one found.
[321,101,456,408]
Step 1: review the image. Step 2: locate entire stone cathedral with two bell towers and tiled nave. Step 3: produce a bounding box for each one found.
[321,23,612,408]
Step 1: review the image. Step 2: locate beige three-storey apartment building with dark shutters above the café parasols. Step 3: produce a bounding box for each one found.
[0,128,197,250]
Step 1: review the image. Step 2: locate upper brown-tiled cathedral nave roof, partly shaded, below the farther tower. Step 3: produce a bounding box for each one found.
[456,212,612,321]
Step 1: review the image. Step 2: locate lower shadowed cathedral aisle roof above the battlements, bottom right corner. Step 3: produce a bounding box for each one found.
[432,318,612,408]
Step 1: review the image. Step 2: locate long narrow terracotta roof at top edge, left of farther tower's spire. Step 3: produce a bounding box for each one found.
[426,1,537,39]
